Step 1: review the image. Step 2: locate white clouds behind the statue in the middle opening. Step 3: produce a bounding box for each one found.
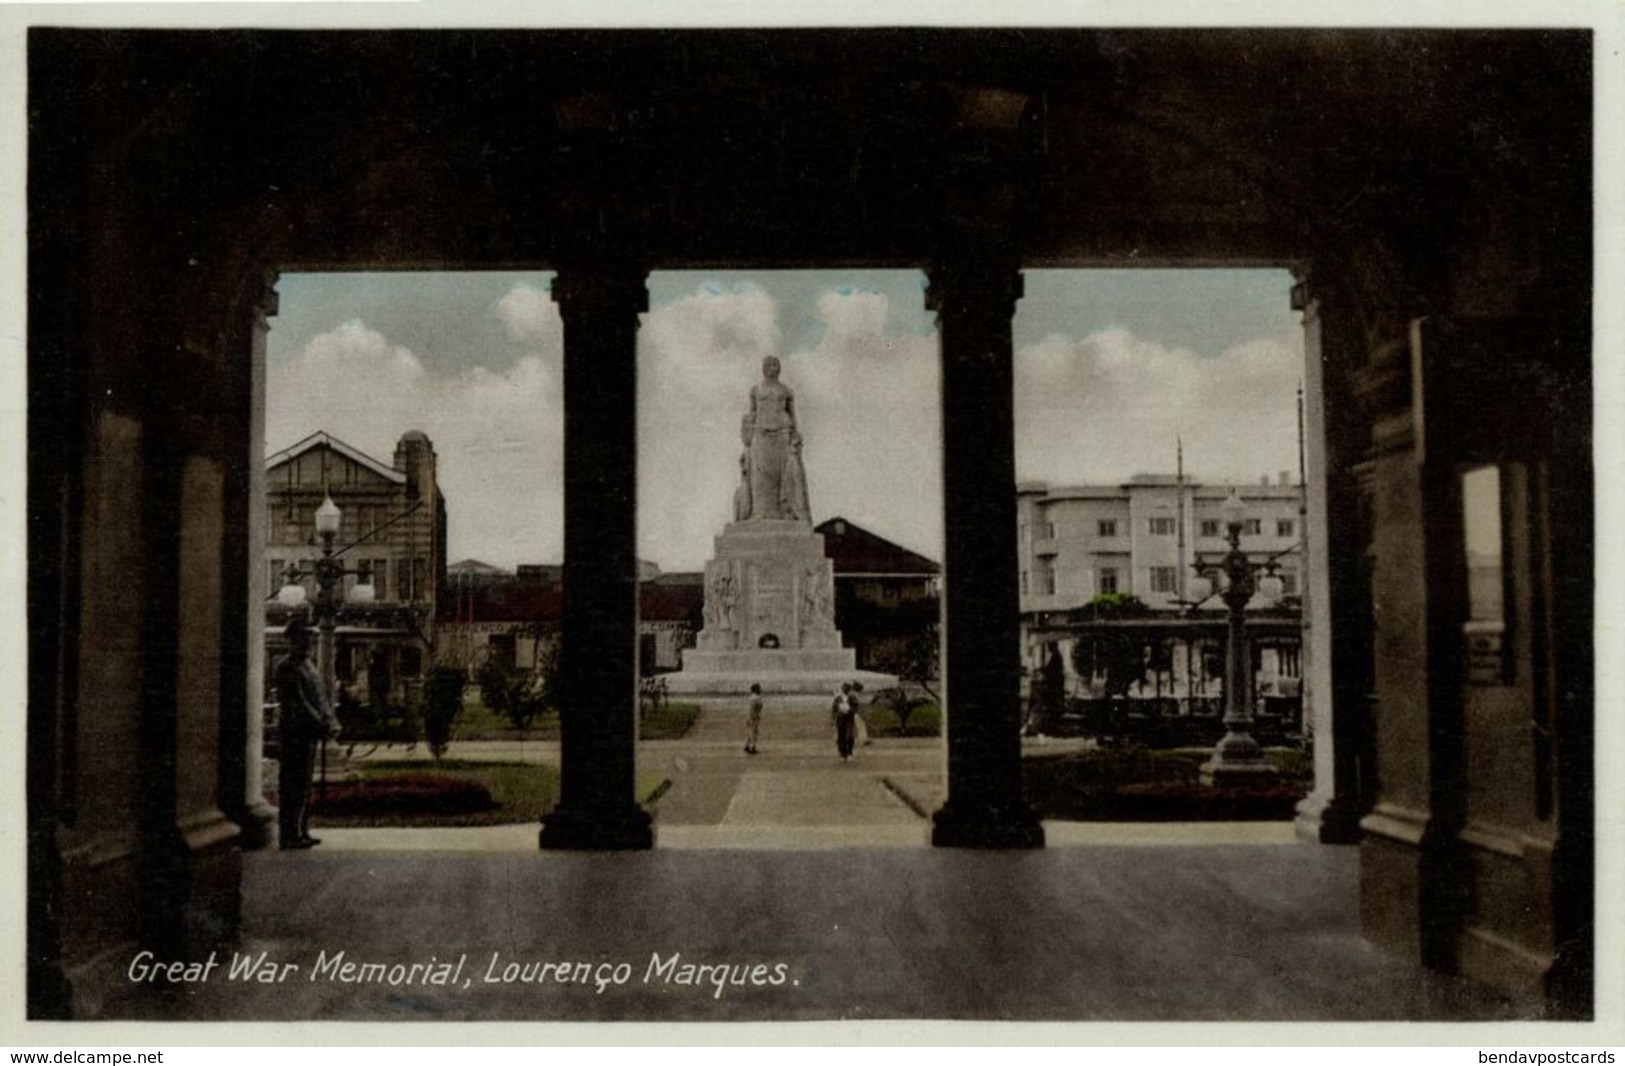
[639,279,941,569]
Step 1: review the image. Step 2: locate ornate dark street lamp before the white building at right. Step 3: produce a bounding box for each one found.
[1191,489,1282,785]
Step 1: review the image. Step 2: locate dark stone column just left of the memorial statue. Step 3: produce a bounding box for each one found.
[541,262,653,850]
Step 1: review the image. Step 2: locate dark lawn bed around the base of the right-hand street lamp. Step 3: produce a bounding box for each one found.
[1022,748,1307,822]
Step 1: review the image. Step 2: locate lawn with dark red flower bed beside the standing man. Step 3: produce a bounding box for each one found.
[310,759,665,829]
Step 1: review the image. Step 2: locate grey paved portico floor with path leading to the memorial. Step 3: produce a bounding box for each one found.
[95,707,1519,1042]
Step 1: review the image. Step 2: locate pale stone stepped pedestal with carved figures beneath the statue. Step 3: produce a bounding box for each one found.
[666,518,897,696]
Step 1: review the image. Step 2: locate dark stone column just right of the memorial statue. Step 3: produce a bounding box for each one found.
[926,257,1043,848]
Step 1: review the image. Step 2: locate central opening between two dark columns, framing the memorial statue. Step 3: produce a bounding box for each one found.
[637,270,943,848]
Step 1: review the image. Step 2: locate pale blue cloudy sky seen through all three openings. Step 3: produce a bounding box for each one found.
[267,270,1303,570]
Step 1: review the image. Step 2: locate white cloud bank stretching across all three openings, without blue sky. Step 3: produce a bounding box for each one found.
[267,284,1302,569]
